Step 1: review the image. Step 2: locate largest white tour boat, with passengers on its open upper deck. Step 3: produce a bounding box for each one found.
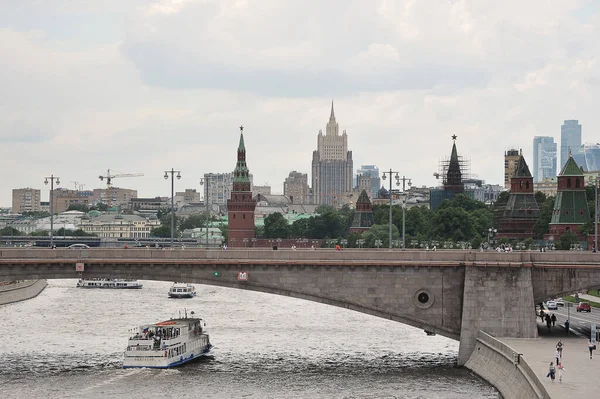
[123,311,212,369]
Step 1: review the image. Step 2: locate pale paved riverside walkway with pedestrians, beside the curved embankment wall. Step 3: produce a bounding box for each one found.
[498,318,600,399]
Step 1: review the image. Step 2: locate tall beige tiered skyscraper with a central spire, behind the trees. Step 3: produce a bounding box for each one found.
[312,101,353,206]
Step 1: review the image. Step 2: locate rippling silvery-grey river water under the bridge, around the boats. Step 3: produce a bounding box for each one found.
[0,280,499,399]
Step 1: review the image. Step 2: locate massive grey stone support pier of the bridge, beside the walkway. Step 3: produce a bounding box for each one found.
[458,266,537,366]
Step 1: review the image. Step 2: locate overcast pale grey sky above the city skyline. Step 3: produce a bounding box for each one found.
[0,0,600,206]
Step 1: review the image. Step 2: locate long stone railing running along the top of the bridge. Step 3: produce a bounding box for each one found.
[0,248,600,267]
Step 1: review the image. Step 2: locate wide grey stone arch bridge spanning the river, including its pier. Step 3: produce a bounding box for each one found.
[0,248,600,365]
